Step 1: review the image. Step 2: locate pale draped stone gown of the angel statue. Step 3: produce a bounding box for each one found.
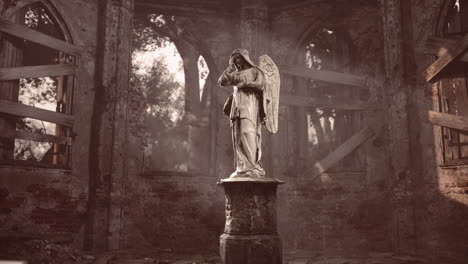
[219,67,265,176]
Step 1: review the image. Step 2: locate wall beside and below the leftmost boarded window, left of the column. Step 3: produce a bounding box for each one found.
[0,0,97,248]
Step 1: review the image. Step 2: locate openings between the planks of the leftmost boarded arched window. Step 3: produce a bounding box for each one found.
[0,1,74,168]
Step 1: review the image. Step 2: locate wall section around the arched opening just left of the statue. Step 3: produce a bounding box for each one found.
[122,11,239,252]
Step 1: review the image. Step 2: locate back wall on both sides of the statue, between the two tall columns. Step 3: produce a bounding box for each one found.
[119,2,392,256]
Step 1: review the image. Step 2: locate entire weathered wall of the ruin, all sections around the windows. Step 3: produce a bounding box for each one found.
[0,0,468,264]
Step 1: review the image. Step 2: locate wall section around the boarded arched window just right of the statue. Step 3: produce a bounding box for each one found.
[273,1,392,256]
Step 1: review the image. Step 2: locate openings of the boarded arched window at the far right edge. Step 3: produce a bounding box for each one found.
[436,0,468,165]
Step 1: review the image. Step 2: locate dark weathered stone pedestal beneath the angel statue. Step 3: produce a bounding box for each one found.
[218,178,283,264]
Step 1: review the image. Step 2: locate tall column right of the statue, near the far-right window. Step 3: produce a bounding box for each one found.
[380,0,420,254]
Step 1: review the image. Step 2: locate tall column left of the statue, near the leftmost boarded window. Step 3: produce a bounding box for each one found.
[84,0,133,251]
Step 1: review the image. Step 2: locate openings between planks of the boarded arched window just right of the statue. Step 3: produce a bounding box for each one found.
[283,20,365,171]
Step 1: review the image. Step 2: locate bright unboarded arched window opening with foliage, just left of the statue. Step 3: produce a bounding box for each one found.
[132,14,210,173]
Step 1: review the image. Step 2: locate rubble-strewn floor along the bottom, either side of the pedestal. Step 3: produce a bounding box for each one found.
[0,240,440,264]
